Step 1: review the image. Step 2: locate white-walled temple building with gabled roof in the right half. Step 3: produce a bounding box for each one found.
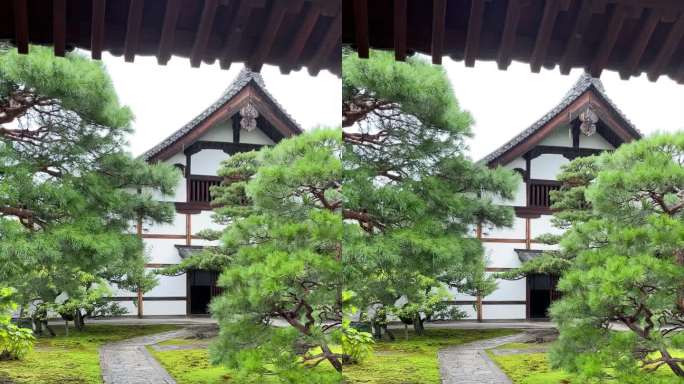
[454,74,641,320]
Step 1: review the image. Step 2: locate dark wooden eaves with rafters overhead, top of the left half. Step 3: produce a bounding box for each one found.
[0,0,341,75]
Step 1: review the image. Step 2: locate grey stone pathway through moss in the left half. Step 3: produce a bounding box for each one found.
[100,328,192,384]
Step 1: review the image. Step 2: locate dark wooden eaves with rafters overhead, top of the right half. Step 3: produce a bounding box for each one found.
[342,0,684,83]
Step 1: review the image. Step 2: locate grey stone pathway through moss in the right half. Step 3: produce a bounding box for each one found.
[438,333,534,384]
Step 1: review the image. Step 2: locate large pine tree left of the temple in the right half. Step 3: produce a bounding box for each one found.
[342,52,519,332]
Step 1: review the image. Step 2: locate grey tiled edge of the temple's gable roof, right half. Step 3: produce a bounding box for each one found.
[480,72,641,163]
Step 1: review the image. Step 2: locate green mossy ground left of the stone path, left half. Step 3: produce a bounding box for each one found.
[0,324,178,384]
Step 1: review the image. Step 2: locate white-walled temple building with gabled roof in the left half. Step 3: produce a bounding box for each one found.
[112,69,302,316]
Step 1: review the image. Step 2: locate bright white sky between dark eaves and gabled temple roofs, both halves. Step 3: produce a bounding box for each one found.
[103,53,684,160]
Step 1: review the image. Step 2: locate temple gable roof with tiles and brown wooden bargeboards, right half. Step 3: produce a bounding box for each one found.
[481,73,641,165]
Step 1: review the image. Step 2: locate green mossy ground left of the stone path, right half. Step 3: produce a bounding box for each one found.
[344,329,517,384]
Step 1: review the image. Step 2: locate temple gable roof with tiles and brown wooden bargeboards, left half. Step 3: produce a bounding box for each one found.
[142,68,302,161]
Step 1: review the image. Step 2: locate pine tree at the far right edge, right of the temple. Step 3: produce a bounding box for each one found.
[551,133,684,383]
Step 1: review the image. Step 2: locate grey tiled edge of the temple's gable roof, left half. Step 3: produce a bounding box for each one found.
[141,67,302,160]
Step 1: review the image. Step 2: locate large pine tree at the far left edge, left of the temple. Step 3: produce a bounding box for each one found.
[0,47,178,328]
